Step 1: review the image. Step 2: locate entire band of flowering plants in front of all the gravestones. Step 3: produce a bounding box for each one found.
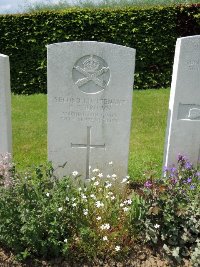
[0,156,200,267]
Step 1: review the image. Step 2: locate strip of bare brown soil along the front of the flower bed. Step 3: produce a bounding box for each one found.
[0,249,192,267]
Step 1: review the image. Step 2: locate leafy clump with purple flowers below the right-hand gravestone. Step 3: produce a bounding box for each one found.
[138,156,200,266]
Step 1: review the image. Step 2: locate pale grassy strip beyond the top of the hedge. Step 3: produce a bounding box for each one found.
[22,0,199,12]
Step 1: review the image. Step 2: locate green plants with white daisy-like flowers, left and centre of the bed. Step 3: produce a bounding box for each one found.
[0,157,134,262]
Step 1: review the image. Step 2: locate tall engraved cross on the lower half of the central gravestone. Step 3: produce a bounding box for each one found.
[71,126,105,179]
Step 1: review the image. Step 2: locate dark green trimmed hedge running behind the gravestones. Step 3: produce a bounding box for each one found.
[0,4,200,94]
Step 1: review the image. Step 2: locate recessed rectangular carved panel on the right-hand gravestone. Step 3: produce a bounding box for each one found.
[178,103,200,121]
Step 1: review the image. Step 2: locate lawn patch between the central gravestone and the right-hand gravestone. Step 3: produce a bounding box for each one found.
[129,89,169,180]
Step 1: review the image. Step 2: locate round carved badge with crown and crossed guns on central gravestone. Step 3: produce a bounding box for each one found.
[72,55,110,94]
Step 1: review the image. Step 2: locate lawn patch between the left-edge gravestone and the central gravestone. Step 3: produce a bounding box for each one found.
[12,95,47,168]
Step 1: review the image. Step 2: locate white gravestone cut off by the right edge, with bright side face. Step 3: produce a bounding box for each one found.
[164,35,200,166]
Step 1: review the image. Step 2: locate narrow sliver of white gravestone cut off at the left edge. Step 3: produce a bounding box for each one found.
[0,54,12,156]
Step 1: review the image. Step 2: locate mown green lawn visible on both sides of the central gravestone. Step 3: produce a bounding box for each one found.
[12,89,169,179]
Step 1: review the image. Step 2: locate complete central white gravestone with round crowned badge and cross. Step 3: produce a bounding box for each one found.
[48,41,135,179]
